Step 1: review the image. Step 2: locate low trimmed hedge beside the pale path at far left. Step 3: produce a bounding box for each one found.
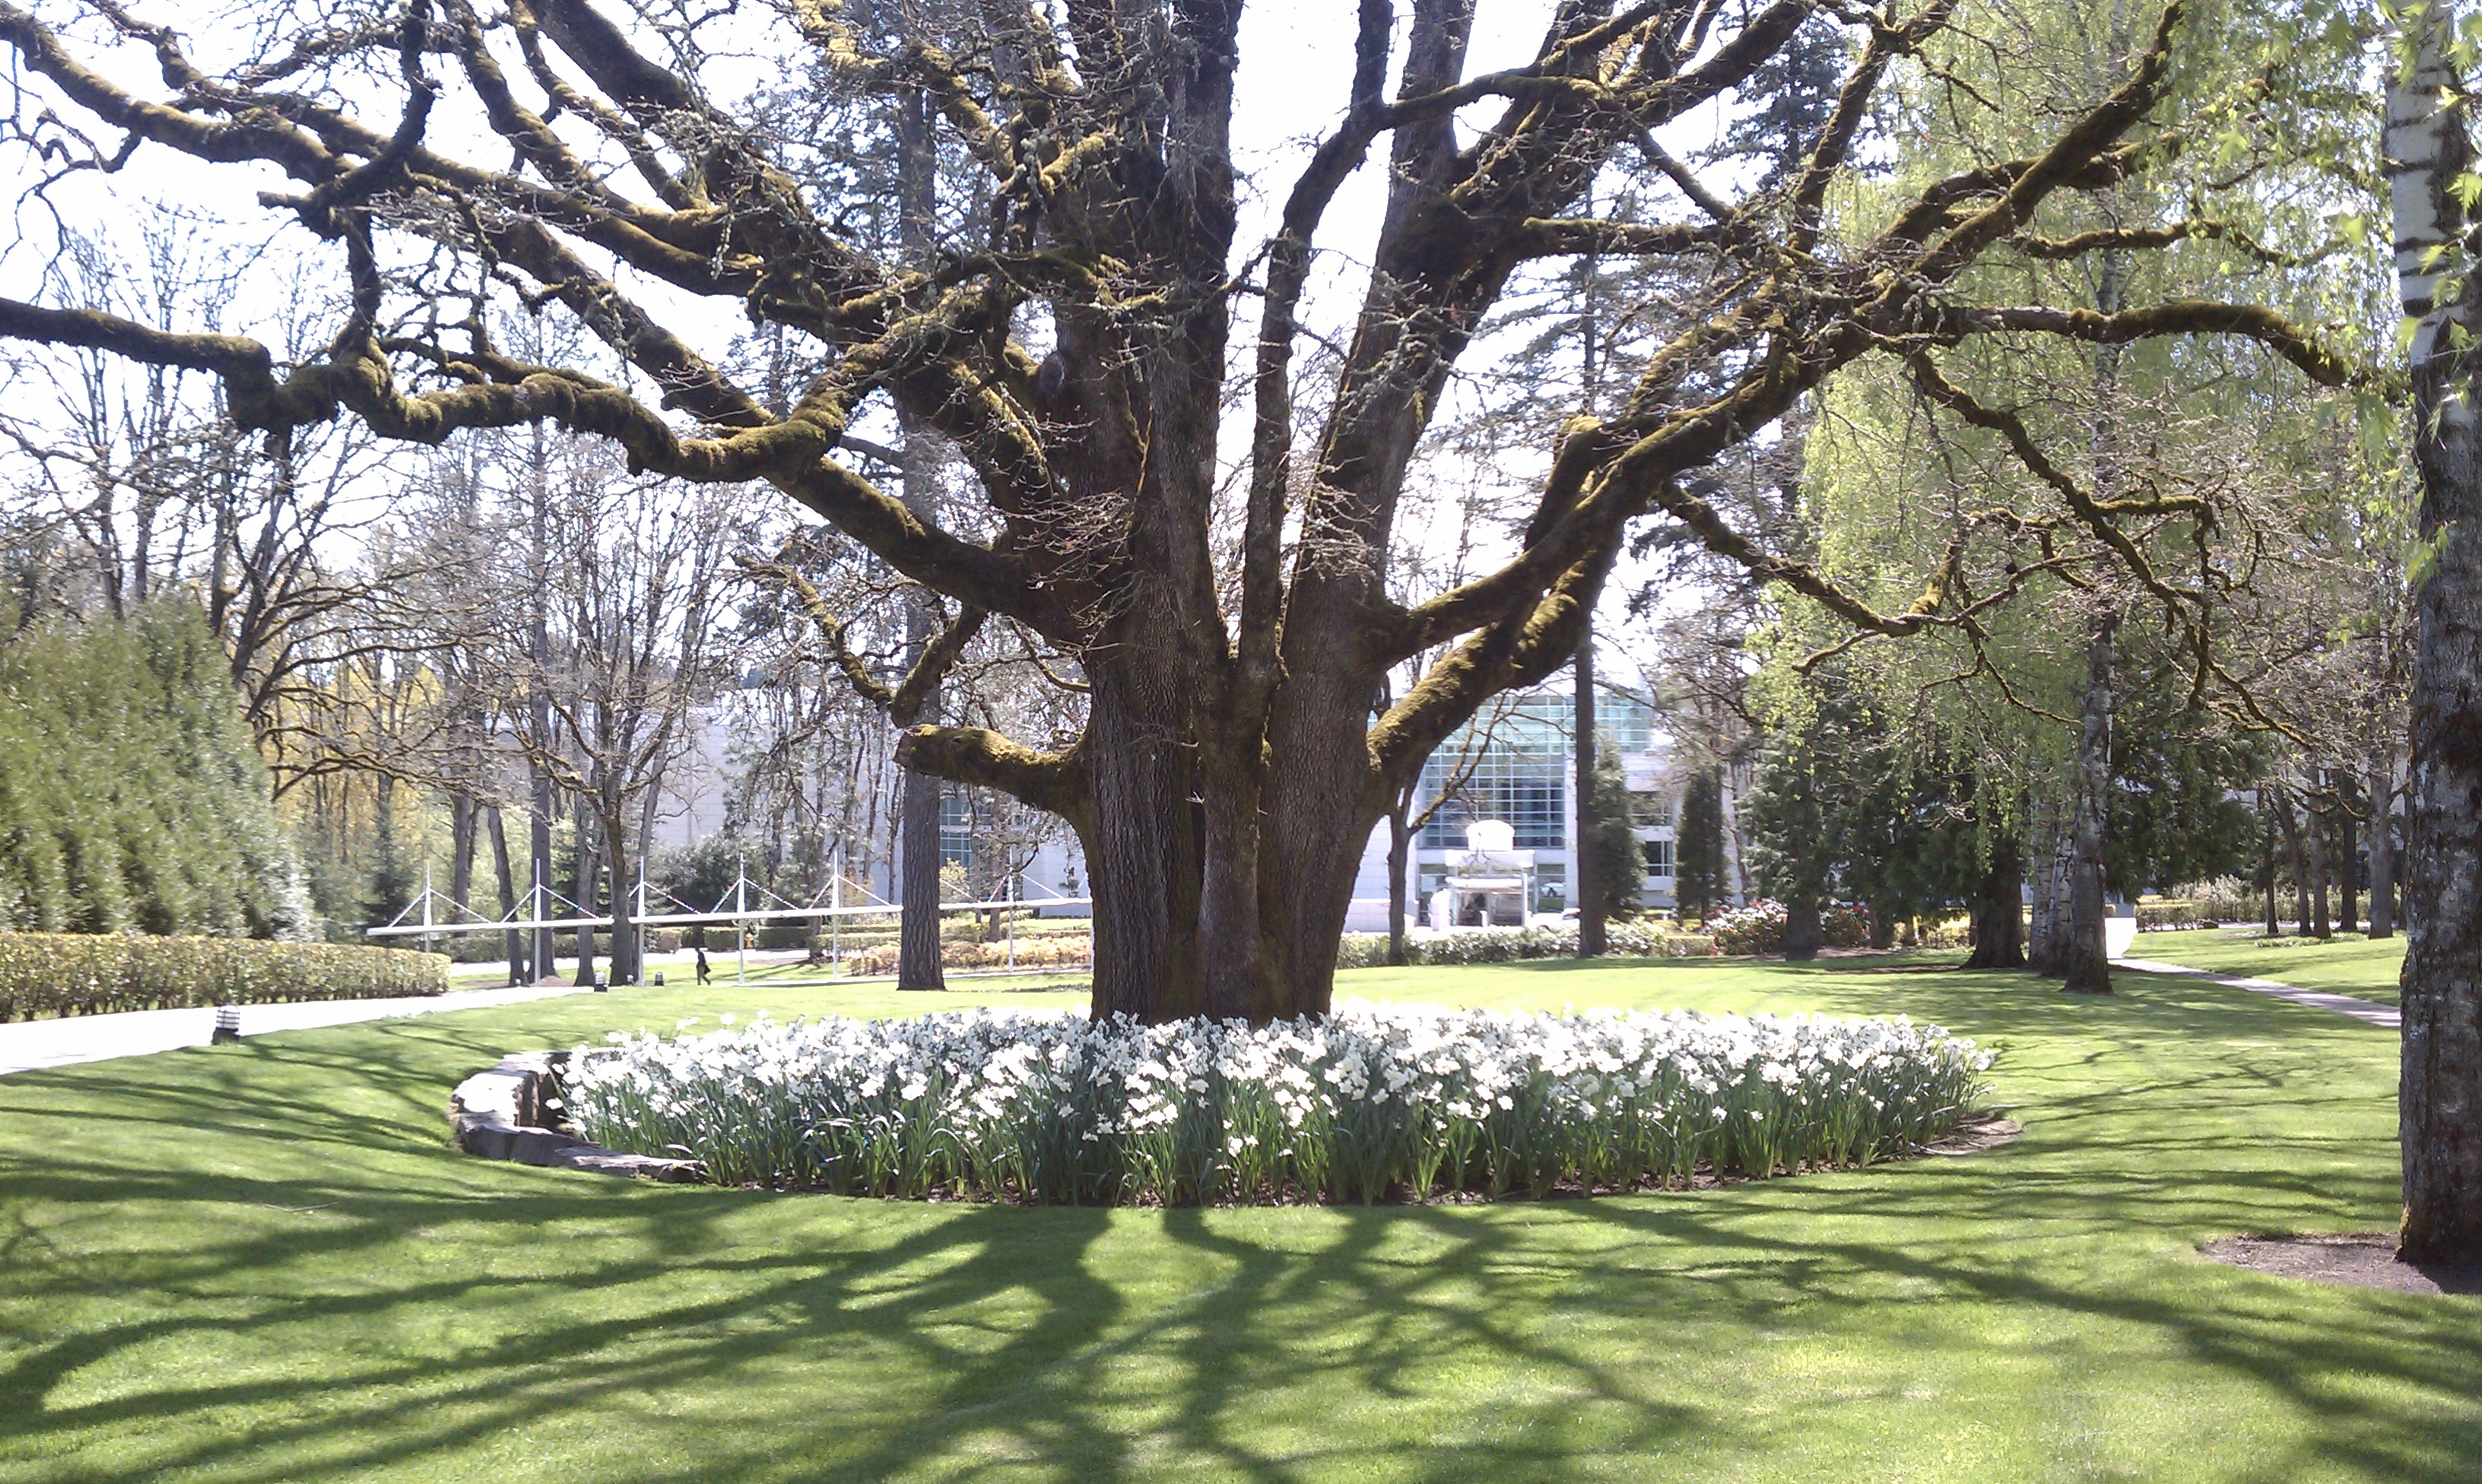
[0,933,449,1020]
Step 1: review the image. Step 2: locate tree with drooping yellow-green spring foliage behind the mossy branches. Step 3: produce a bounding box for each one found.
[1757,0,2390,988]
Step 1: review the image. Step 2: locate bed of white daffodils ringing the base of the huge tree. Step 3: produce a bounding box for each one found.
[563,1005,1991,1203]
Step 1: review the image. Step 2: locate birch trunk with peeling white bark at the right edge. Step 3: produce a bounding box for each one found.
[2385,0,2482,1263]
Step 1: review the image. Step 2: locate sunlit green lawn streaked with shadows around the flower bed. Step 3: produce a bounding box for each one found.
[0,960,2482,1484]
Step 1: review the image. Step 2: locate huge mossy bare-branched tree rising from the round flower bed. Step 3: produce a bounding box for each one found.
[0,0,2343,1017]
